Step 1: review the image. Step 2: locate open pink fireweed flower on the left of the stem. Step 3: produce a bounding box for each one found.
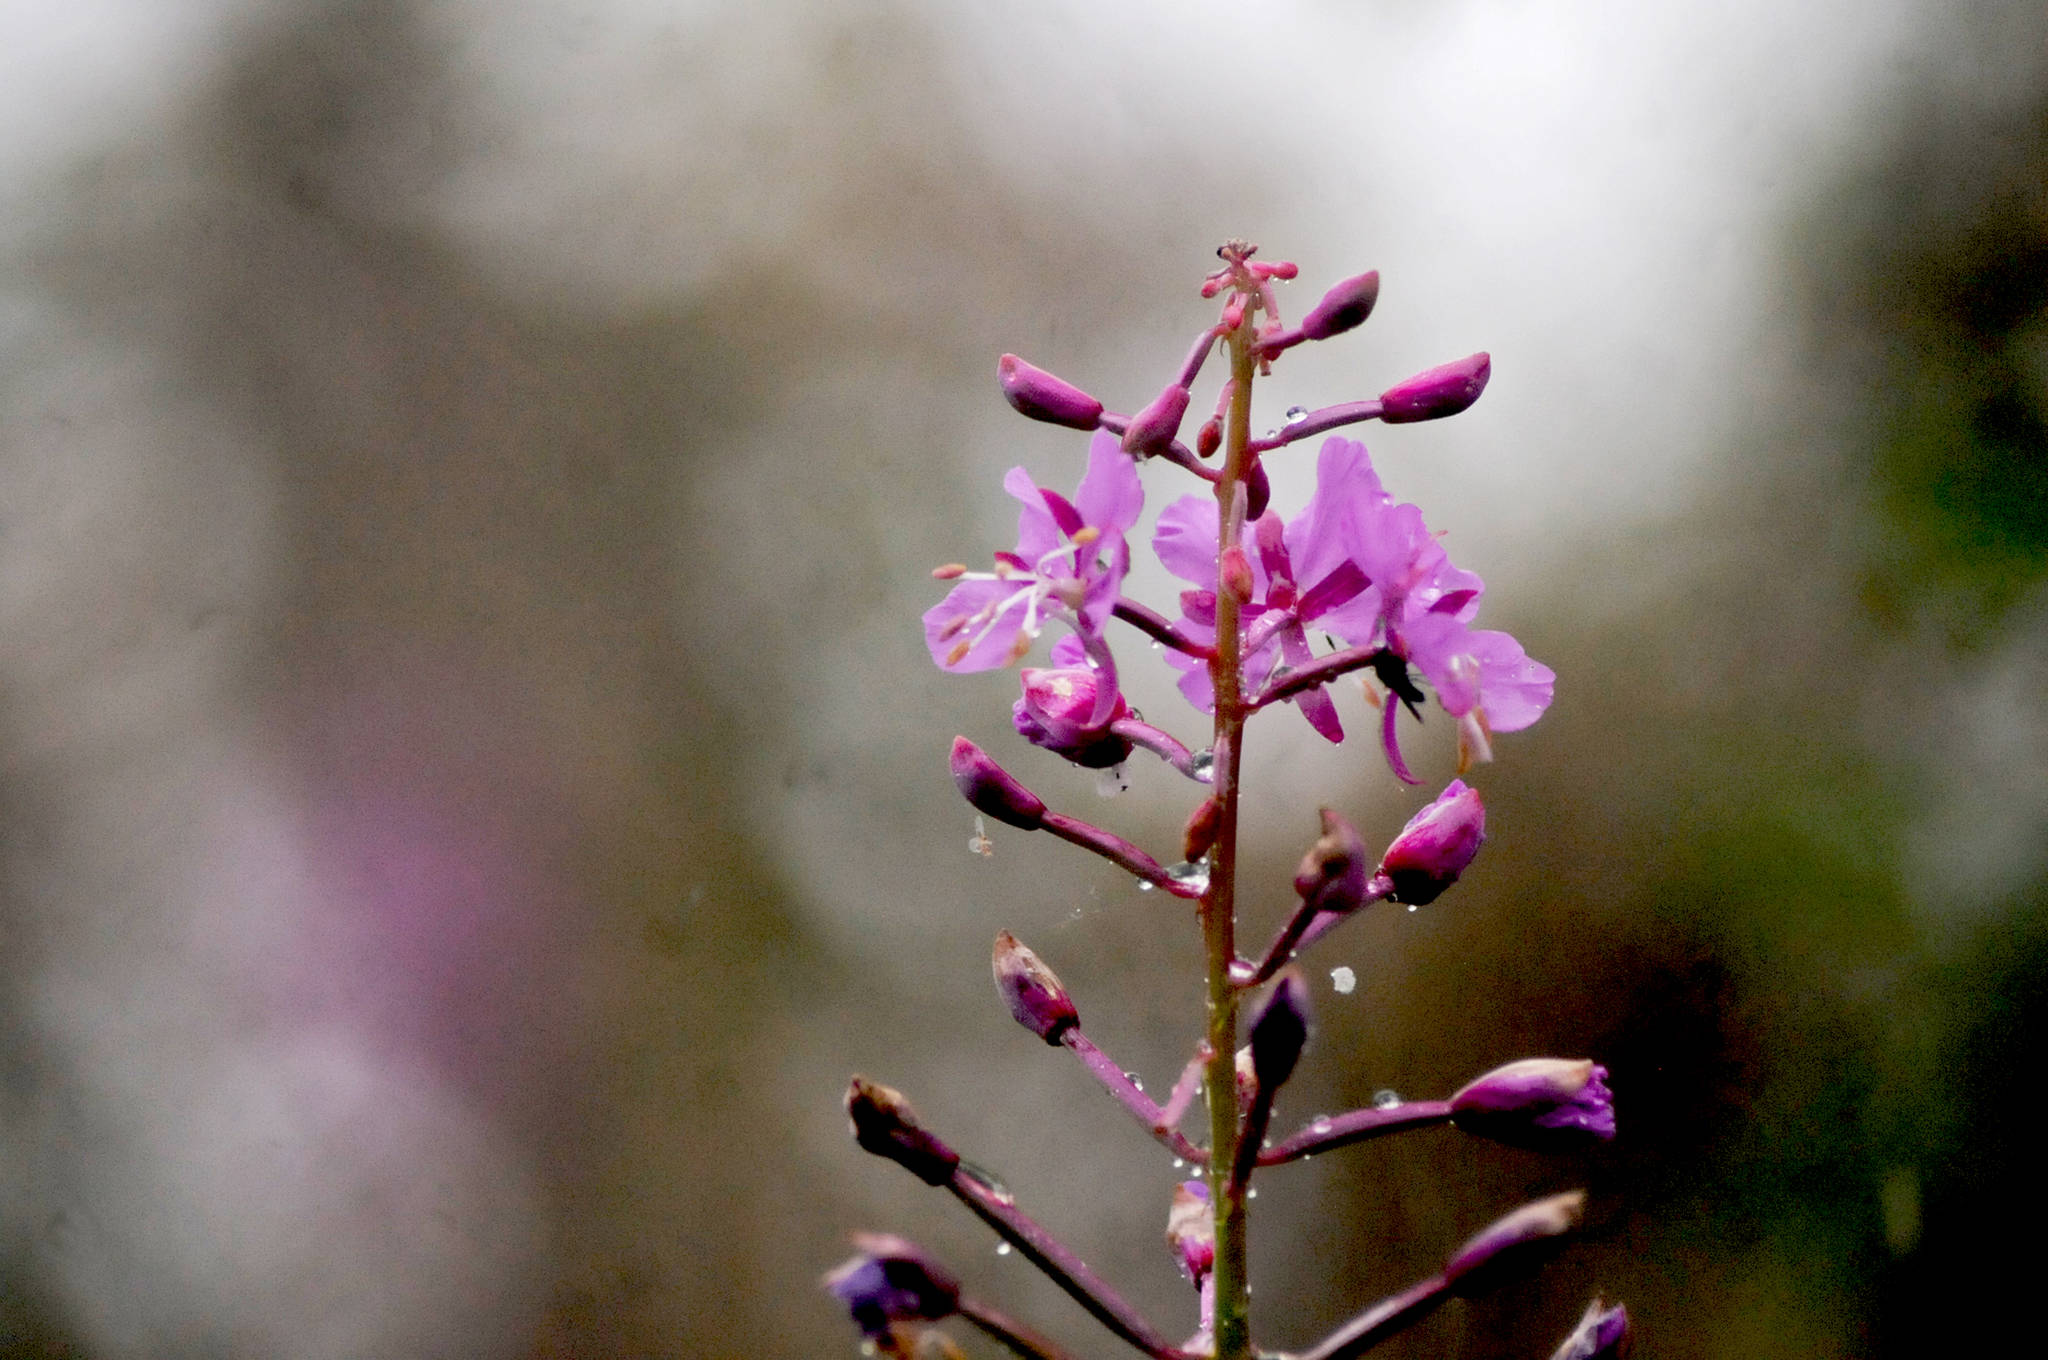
[924,432,1145,721]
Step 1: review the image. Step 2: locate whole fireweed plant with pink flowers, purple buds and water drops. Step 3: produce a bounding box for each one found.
[825,242,1628,1360]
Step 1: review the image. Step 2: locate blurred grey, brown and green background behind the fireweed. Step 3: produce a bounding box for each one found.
[0,0,2048,1360]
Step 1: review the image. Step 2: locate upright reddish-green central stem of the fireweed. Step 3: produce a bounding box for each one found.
[1202,317,1257,1360]
